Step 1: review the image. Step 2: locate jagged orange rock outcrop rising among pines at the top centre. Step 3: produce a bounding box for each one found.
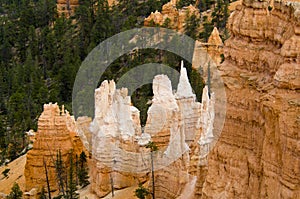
[144,0,200,33]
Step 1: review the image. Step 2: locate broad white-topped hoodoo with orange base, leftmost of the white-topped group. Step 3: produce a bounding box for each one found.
[91,80,148,197]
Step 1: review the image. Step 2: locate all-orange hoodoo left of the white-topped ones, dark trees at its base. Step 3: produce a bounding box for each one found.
[24,103,83,194]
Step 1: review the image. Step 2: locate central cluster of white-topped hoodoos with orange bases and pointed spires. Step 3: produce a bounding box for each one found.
[91,65,214,198]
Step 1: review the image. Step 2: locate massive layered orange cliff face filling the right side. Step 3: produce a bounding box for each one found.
[203,0,300,198]
